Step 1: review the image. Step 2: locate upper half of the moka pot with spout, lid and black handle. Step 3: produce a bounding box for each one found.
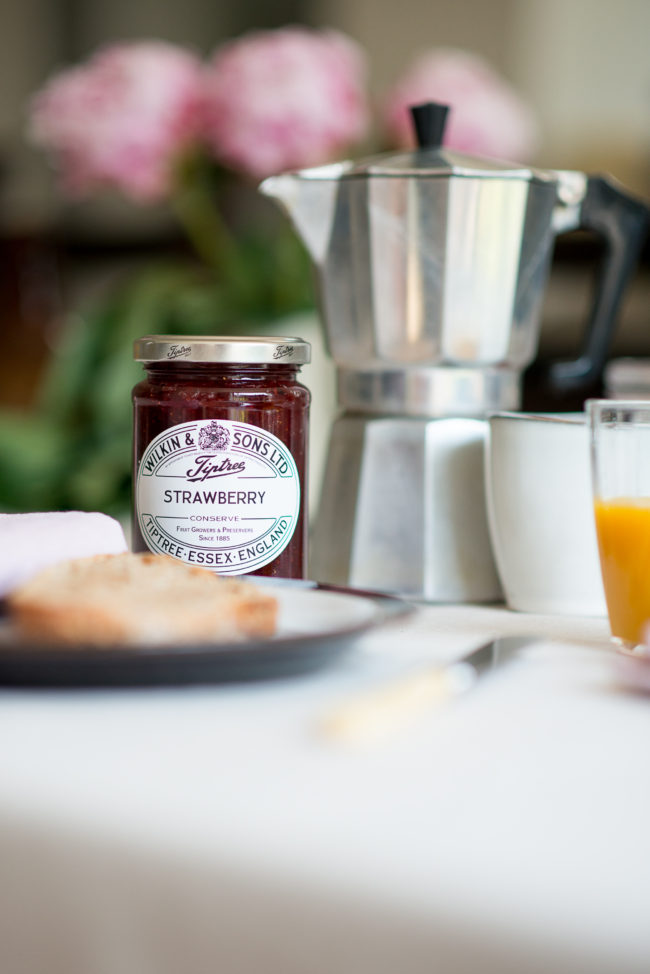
[260,103,648,415]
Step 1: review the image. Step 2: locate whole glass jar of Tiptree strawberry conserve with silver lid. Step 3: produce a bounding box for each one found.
[133,335,311,578]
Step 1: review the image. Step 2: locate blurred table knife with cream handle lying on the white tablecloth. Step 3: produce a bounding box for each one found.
[318,636,538,741]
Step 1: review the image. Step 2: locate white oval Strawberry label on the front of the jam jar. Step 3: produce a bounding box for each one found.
[136,419,300,575]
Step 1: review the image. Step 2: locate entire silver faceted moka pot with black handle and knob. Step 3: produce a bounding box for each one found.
[261,104,647,602]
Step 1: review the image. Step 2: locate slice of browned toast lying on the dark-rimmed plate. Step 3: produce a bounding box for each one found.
[7,553,278,647]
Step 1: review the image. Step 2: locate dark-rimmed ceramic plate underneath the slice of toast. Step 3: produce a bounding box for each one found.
[0,578,412,687]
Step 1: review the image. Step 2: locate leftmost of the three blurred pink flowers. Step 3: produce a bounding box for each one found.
[31,41,203,201]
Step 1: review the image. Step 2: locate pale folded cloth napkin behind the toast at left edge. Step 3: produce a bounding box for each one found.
[0,511,127,598]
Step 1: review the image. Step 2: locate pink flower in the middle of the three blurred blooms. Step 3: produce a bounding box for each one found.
[202,27,368,179]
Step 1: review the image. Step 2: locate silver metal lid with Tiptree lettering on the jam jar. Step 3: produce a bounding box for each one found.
[133,335,311,365]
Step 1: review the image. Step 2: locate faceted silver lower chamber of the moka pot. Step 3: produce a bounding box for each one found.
[309,412,503,602]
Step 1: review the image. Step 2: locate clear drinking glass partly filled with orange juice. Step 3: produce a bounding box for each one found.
[586,399,650,653]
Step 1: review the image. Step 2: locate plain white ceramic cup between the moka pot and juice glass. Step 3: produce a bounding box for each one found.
[485,413,607,616]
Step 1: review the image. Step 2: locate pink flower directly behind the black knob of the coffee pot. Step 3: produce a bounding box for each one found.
[384,47,538,160]
